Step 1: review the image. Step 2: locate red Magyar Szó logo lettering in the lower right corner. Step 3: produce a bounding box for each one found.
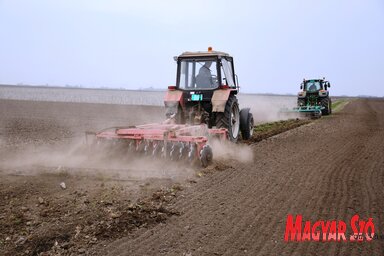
[284,214,378,242]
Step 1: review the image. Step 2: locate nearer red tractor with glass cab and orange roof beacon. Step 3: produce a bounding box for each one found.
[164,48,254,142]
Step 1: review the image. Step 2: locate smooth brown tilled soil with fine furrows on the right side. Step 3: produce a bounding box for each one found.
[101,100,384,255]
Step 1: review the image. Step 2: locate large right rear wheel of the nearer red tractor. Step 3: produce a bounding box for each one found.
[215,95,240,142]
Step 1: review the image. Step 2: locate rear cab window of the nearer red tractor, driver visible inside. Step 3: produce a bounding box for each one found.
[178,58,218,90]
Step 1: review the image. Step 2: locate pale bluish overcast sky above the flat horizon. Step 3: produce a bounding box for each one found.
[0,0,384,96]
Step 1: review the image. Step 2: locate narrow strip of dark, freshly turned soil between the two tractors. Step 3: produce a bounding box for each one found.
[248,119,311,144]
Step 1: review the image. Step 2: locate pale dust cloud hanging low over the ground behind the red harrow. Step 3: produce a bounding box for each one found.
[1,140,195,181]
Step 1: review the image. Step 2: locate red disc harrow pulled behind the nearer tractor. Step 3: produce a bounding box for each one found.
[86,123,228,167]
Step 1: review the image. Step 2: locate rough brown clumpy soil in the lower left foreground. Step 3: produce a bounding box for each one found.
[0,176,182,255]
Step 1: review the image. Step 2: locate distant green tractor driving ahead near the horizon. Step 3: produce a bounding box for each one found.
[297,78,332,116]
